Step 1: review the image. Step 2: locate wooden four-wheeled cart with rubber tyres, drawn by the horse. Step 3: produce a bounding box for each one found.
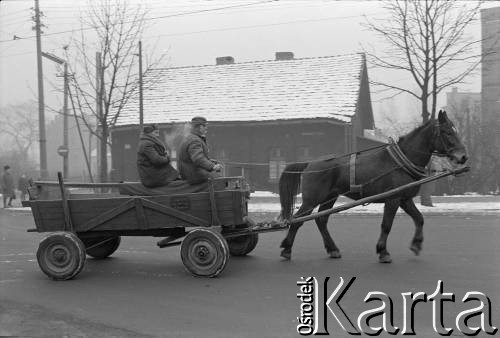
[23,174,258,280]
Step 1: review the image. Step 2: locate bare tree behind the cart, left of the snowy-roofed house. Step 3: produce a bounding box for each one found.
[69,0,161,181]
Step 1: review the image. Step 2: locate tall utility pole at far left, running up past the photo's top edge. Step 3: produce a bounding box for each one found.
[34,0,48,179]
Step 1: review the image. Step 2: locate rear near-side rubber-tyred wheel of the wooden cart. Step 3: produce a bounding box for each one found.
[36,232,85,280]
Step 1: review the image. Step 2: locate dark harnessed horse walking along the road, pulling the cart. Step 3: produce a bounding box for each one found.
[279,111,467,263]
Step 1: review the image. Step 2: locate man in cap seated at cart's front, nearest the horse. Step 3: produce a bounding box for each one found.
[179,116,222,184]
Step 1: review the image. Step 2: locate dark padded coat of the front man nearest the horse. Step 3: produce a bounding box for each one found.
[179,133,216,184]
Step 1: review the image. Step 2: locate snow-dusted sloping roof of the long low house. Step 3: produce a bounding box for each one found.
[116,53,364,126]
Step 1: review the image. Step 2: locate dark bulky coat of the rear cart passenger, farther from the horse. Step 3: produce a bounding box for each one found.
[137,134,179,188]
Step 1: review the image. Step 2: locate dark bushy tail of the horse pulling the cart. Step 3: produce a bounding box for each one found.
[279,162,309,220]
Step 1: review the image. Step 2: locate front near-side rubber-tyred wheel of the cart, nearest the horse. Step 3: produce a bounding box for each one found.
[181,229,229,277]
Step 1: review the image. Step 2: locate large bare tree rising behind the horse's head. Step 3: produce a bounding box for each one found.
[366,0,481,122]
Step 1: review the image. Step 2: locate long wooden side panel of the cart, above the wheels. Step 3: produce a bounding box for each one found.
[25,190,247,232]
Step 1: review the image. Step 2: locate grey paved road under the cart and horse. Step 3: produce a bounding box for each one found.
[0,211,500,337]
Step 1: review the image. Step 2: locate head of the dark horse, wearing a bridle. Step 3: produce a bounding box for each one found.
[433,110,467,164]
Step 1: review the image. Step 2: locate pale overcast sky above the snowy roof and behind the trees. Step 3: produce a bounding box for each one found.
[0,0,500,129]
